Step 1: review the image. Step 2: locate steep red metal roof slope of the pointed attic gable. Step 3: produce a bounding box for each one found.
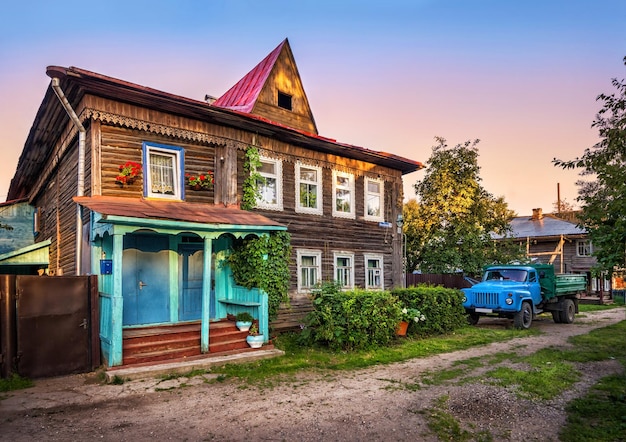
[213,39,287,113]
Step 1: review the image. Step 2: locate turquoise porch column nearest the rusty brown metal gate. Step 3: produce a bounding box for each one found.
[109,233,124,367]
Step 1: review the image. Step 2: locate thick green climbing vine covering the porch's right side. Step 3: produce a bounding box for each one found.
[228,231,291,320]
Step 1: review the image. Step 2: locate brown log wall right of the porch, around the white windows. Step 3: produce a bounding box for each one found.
[238,144,403,331]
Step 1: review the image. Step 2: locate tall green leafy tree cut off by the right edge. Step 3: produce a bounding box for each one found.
[552,57,626,270]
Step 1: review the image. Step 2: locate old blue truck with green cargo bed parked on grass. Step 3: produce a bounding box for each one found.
[462,264,587,329]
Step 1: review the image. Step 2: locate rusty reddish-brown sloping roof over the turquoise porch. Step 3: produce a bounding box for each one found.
[74,196,287,230]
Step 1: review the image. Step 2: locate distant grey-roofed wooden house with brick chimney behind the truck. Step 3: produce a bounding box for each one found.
[511,209,610,293]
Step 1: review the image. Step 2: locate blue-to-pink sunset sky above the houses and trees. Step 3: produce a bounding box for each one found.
[0,0,626,215]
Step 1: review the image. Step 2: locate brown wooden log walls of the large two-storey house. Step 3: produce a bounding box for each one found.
[26,91,402,330]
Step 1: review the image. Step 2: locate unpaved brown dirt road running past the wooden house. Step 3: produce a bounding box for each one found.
[0,308,626,441]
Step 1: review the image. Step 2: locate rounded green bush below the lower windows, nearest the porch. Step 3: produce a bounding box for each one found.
[301,282,402,351]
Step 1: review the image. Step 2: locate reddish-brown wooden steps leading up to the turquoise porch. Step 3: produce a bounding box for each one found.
[122,321,255,366]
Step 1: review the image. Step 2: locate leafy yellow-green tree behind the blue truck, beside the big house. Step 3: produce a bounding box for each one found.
[403,137,523,275]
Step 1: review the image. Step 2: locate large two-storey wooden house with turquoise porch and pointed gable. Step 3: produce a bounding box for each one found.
[3,40,423,366]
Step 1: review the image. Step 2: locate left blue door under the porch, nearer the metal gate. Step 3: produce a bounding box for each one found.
[122,235,170,325]
